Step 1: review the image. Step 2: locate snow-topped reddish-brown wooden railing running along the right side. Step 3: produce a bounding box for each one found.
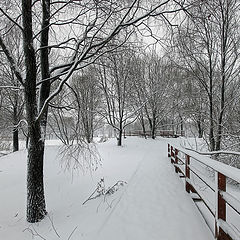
[168,144,240,240]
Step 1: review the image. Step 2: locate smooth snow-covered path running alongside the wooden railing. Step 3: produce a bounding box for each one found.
[96,139,214,240]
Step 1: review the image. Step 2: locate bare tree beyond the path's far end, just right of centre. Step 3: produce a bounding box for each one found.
[133,50,174,139]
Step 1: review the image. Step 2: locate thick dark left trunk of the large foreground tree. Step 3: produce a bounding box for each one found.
[22,0,46,223]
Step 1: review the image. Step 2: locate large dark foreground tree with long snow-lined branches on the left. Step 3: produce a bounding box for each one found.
[0,0,188,222]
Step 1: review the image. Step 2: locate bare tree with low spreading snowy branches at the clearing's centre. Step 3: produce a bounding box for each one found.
[97,48,138,146]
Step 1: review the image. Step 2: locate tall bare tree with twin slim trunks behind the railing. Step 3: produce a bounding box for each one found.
[172,0,239,151]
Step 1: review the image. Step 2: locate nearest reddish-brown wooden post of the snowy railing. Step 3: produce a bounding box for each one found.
[215,172,232,240]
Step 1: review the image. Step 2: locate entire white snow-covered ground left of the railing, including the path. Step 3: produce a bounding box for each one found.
[0,137,214,240]
